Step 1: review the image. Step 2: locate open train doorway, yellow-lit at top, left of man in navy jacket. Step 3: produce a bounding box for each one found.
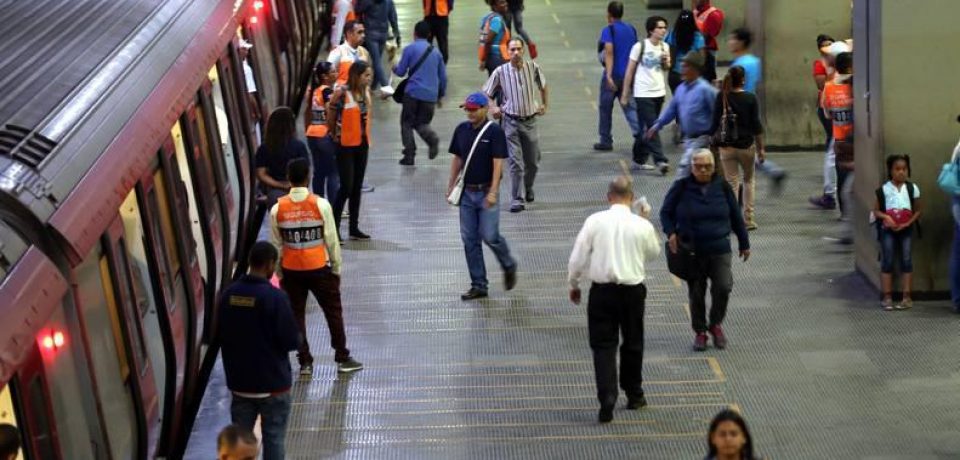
[114,190,173,455]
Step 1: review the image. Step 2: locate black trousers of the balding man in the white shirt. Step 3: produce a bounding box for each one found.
[587,283,647,407]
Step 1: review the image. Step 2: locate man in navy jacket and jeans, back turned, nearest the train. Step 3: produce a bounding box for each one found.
[217,241,300,460]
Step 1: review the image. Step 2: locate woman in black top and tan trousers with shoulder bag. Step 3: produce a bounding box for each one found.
[711,66,766,230]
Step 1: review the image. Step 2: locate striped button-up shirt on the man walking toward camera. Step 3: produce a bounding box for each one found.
[483,61,547,117]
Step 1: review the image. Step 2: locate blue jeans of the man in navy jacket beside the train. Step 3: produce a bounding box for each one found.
[230,391,290,460]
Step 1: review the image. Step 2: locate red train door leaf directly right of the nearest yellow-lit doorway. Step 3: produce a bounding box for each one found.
[140,167,196,453]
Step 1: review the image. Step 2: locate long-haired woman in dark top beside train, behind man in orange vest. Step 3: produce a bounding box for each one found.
[255,107,310,239]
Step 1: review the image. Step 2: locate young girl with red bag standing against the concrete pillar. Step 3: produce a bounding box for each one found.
[873,155,921,311]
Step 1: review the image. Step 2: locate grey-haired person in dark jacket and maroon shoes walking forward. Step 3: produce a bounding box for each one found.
[660,149,750,351]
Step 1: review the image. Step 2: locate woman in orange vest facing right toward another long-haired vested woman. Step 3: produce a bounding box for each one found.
[303,61,340,203]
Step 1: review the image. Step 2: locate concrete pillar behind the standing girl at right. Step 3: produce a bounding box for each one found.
[854,0,960,297]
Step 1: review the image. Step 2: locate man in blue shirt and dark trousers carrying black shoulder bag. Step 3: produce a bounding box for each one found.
[393,21,447,166]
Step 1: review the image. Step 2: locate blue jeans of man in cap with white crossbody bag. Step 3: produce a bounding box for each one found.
[460,189,517,291]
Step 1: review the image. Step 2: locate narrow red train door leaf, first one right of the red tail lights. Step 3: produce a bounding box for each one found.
[103,218,162,458]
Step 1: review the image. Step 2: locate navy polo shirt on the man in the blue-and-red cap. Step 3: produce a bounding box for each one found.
[450,121,507,185]
